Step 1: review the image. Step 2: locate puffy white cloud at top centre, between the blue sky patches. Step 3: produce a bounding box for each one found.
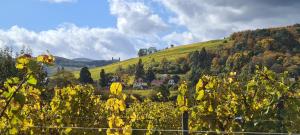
[109,0,168,36]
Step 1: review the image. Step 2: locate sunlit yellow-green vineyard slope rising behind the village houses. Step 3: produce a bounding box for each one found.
[74,40,229,80]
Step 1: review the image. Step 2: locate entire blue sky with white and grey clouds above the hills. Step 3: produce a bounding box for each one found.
[0,0,300,59]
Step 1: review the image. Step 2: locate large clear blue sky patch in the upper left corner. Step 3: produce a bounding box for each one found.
[0,0,116,31]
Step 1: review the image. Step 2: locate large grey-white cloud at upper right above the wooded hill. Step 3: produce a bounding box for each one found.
[158,0,300,41]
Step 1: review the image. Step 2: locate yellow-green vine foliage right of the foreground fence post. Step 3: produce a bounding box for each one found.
[189,68,299,132]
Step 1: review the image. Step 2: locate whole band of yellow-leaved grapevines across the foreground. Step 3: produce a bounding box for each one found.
[0,55,300,135]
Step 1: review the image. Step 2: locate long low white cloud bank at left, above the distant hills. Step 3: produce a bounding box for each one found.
[0,24,136,59]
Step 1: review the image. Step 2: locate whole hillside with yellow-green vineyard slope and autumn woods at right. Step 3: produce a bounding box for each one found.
[75,24,300,80]
